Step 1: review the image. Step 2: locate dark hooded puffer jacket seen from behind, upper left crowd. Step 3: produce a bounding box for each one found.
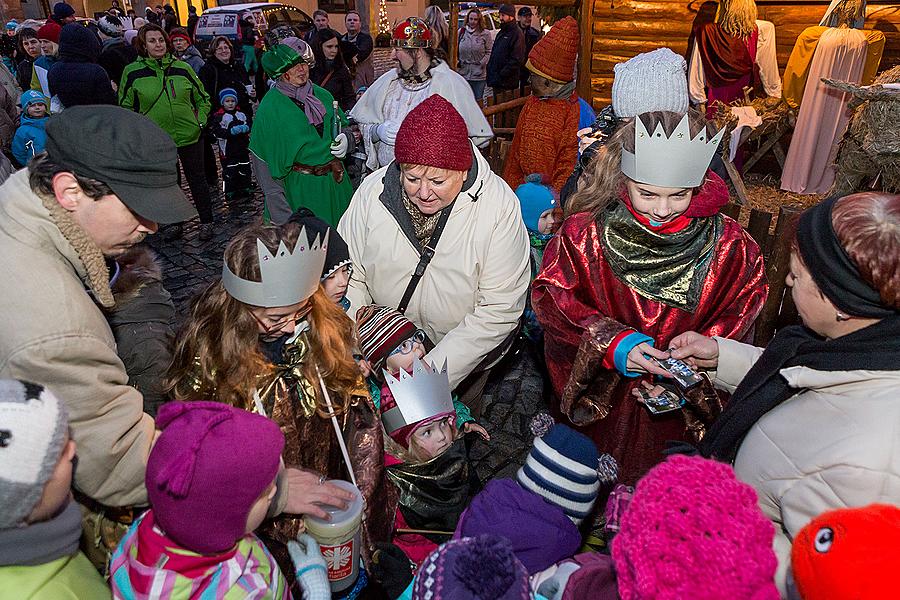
[47,23,116,108]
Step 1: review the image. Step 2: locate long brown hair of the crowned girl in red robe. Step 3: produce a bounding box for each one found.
[565,109,715,218]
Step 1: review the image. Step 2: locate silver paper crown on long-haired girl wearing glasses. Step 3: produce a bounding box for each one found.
[222,227,328,307]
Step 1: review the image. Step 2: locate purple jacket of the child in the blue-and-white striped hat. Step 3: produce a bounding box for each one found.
[453,479,581,575]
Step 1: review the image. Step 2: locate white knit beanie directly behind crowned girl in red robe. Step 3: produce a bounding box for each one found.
[612,48,689,118]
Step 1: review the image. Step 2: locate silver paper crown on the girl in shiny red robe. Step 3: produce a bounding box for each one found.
[622,115,725,188]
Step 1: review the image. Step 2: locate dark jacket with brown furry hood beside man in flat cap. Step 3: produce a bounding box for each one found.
[106,246,175,416]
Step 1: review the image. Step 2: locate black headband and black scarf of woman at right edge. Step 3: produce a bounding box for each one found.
[700,198,900,462]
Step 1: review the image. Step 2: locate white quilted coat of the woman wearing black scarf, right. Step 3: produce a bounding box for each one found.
[716,338,900,596]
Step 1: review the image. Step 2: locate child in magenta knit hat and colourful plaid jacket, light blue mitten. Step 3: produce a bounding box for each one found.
[110,401,330,600]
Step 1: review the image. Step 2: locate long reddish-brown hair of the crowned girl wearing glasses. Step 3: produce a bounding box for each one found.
[166,223,360,416]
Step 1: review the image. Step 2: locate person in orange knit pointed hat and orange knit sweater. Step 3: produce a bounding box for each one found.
[503,17,596,195]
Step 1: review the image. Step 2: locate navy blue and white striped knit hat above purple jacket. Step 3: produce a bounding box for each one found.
[516,424,600,525]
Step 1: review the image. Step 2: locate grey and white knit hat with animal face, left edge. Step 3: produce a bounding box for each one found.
[0,379,69,529]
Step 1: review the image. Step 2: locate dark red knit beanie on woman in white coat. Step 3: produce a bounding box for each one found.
[394,94,472,171]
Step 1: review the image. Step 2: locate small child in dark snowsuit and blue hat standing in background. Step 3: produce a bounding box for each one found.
[213,88,253,198]
